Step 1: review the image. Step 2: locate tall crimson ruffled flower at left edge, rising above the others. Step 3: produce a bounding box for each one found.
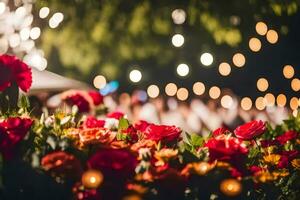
[0,55,32,92]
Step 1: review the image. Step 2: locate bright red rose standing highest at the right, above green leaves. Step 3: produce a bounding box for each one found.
[234,120,266,140]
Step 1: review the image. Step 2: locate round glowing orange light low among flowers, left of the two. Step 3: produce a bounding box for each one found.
[81,170,103,189]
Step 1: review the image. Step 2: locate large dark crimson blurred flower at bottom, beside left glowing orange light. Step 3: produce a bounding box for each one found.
[88,149,137,181]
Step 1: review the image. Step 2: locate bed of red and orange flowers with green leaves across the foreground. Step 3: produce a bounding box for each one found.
[0,56,300,200]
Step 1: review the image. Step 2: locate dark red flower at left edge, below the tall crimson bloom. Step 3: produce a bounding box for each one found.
[0,117,32,159]
